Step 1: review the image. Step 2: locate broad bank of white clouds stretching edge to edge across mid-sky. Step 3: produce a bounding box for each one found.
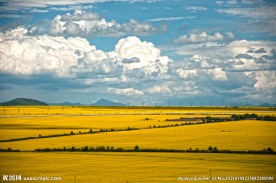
[0,27,276,102]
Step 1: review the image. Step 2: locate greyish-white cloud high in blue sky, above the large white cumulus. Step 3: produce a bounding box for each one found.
[30,10,164,37]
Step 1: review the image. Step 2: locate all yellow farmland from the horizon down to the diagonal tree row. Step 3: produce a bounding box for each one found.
[0,106,276,140]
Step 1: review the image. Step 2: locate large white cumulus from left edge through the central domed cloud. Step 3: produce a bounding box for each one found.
[0,27,172,85]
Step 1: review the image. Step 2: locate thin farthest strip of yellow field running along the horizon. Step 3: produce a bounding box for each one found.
[0,106,276,116]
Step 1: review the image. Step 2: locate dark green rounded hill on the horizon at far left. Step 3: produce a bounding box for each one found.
[0,98,48,106]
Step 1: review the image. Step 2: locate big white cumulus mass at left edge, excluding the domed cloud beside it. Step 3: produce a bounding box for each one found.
[0,28,96,77]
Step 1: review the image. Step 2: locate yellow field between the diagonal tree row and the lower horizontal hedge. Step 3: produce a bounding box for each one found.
[0,120,276,150]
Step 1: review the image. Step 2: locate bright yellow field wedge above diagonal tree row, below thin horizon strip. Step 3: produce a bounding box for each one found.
[0,115,184,140]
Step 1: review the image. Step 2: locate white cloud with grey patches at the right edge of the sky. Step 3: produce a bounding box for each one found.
[177,40,276,72]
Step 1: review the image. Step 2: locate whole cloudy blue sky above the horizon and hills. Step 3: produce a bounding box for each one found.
[0,0,276,105]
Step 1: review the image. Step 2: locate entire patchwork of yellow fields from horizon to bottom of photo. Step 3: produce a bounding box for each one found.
[0,107,276,182]
